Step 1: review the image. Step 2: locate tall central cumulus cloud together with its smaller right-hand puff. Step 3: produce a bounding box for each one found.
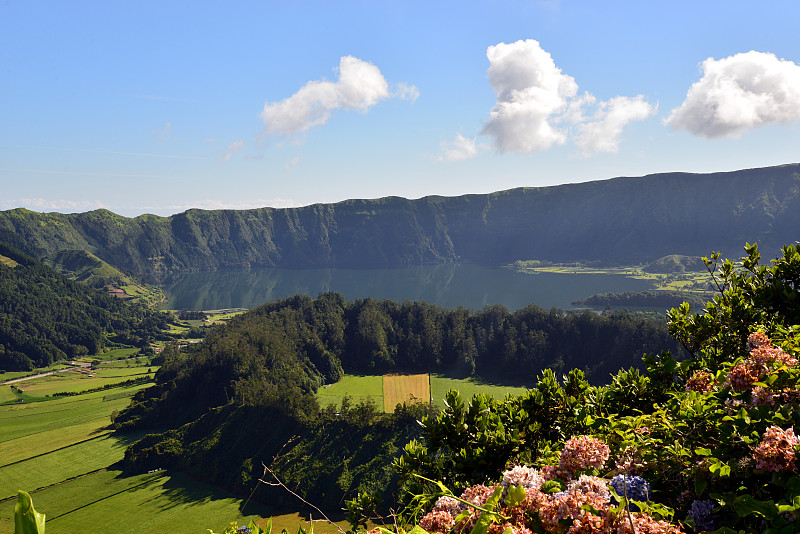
[482,39,655,154]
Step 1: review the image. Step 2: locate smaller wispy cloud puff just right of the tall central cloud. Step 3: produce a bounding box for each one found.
[575,95,656,154]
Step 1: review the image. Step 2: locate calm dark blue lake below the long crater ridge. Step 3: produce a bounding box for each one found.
[163,264,653,311]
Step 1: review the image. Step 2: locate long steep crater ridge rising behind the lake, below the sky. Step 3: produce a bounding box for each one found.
[0,164,800,277]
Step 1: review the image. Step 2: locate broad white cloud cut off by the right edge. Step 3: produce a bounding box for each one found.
[664,51,800,138]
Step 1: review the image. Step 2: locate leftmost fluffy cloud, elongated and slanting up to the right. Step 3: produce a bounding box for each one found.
[261,56,419,136]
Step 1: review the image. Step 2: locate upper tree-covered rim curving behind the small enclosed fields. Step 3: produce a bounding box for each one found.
[120,293,681,432]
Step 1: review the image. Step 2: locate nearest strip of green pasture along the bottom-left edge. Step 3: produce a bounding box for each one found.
[0,469,350,534]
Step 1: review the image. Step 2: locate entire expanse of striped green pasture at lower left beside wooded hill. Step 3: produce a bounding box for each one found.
[0,367,352,534]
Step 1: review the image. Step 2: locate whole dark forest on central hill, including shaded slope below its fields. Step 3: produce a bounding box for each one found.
[114,293,683,510]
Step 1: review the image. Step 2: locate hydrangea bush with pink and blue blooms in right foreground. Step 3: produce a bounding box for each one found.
[380,245,800,534]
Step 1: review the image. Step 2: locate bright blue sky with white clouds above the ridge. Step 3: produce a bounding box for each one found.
[0,0,800,216]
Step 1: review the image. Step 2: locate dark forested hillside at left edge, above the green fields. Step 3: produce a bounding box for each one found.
[0,244,167,370]
